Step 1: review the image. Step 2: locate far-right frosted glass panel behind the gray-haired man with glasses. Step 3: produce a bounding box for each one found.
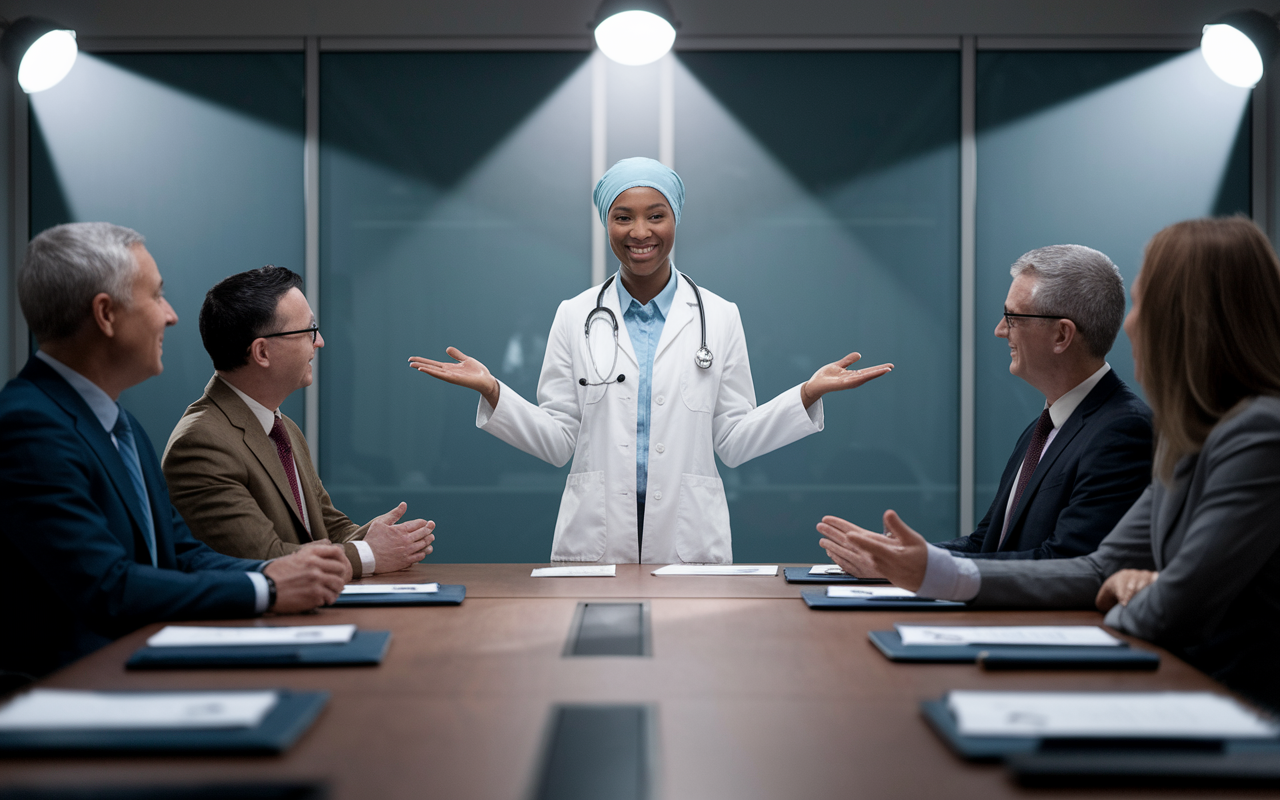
[974,51,1249,518]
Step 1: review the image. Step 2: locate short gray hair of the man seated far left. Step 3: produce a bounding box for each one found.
[18,223,146,342]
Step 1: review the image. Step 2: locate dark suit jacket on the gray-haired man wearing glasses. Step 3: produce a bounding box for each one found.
[938,371,1152,558]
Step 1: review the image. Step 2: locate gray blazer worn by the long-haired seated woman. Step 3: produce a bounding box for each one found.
[973,397,1280,708]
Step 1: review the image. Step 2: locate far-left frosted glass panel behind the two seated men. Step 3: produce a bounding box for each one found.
[31,52,303,451]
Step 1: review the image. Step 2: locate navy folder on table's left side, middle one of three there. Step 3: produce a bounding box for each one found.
[124,631,392,669]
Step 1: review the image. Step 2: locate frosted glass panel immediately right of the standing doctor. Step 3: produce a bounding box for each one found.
[675,52,960,562]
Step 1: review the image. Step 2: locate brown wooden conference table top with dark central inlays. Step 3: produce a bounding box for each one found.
[0,564,1260,800]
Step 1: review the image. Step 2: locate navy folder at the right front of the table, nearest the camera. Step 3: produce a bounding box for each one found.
[920,698,1280,763]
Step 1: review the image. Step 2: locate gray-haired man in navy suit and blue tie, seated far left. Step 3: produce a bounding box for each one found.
[0,223,351,682]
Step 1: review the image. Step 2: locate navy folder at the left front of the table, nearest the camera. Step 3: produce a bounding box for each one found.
[0,689,329,756]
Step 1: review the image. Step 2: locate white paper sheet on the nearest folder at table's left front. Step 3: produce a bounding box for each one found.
[0,689,279,731]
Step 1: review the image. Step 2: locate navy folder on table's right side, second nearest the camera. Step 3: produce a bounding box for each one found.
[869,631,1160,669]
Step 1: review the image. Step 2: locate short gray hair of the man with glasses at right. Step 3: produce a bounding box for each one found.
[1009,244,1124,358]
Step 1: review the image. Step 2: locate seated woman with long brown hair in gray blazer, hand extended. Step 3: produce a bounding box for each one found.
[818,218,1280,709]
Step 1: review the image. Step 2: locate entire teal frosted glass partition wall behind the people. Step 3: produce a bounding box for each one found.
[31,50,1251,562]
